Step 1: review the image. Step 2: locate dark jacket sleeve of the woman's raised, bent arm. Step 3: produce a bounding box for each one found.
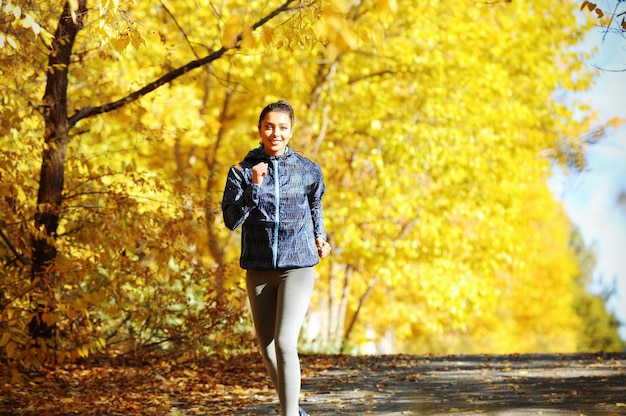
[222,166,259,230]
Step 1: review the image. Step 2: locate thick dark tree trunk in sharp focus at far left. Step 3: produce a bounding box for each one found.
[29,0,87,339]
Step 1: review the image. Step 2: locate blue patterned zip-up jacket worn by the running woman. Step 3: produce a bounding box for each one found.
[222,146,326,270]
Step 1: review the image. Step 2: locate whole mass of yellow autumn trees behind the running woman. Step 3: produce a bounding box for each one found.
[0,0,616,362]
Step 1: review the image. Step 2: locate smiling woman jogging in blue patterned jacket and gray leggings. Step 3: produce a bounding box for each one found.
[222,100,331,416]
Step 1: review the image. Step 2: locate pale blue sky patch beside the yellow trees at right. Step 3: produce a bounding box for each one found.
[555,1,626,340]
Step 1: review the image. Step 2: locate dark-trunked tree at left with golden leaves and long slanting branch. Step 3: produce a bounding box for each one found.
[2,0,336,359]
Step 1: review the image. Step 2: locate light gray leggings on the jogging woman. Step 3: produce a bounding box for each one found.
[246,267,315,416]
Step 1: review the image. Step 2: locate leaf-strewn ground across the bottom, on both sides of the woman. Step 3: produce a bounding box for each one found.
[0,354,626,416]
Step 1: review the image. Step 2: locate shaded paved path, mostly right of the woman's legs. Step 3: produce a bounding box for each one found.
[235,354,626,416]
